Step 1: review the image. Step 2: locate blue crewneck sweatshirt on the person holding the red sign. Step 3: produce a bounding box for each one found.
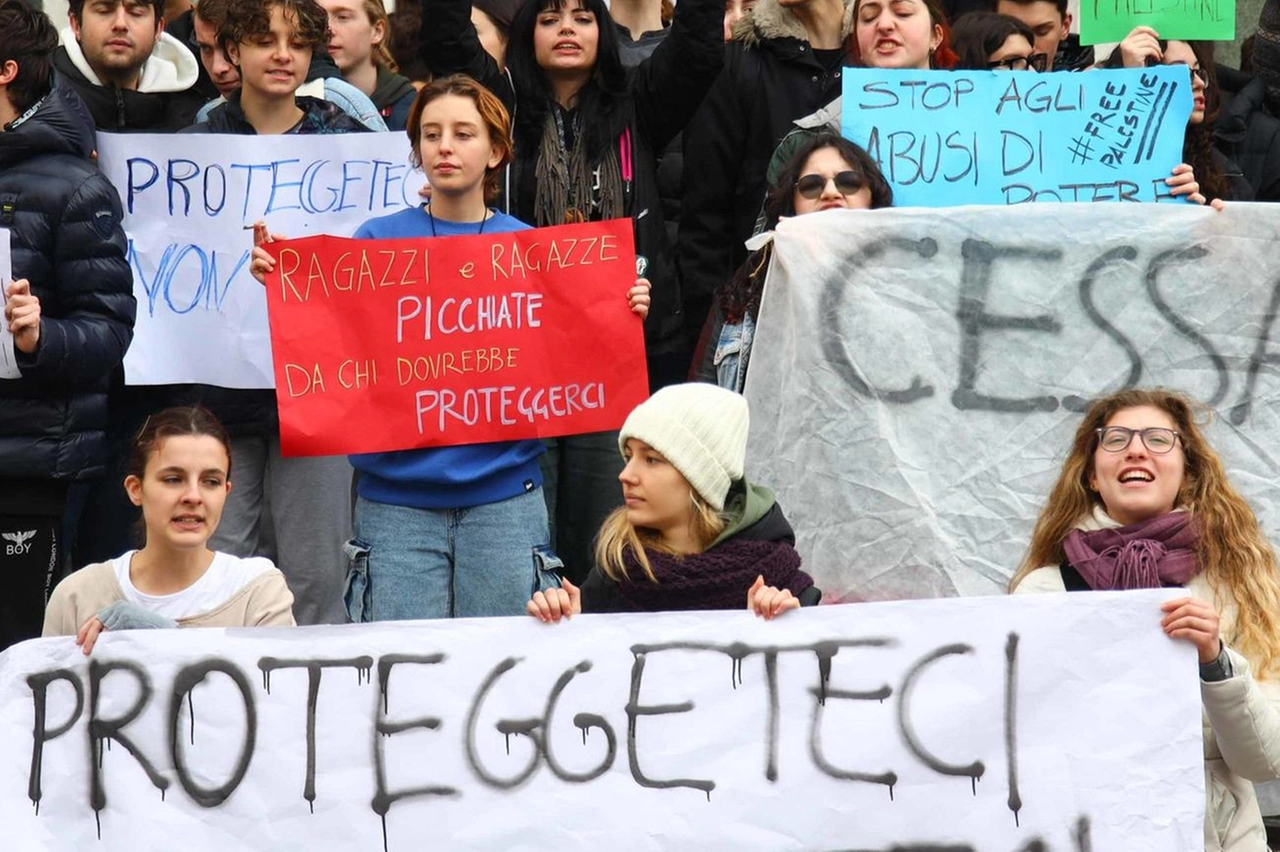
[351,207,543,509]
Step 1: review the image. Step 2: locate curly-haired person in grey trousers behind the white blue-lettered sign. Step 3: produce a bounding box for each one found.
[177,0,367,624]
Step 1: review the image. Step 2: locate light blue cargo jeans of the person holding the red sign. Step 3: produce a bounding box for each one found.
[344,489,561,622]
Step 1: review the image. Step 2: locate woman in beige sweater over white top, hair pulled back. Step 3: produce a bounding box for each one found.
[44,408,294,654]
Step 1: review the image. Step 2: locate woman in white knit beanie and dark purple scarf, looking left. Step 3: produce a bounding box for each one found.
[529,384,822,622]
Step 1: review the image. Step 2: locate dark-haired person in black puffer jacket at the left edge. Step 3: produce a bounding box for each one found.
[0,0,136,650]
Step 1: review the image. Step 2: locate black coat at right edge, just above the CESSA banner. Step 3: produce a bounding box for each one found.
[1213,65,1280,201]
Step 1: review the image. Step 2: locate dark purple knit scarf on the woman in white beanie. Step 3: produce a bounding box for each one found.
[618,539,813,613]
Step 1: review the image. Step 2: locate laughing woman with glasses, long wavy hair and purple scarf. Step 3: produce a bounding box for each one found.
[1010,389,1280,852]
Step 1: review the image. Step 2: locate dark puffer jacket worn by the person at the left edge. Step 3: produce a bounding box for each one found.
[0,88,137,483]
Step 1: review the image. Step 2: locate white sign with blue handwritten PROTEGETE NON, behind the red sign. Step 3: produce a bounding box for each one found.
[97,133,425,388]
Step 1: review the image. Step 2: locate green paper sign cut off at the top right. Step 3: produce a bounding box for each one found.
[1080,0,1235,45]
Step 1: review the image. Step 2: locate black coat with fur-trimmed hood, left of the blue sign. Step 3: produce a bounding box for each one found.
[677,0,849,329]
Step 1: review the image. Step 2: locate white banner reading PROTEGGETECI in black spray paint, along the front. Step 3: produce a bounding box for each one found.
[0,591,1204,852]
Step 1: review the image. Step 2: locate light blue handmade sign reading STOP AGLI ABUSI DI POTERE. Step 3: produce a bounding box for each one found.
[841,65,1192,207]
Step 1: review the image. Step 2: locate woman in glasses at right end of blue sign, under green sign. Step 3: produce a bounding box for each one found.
[1106,27,1254,206]
